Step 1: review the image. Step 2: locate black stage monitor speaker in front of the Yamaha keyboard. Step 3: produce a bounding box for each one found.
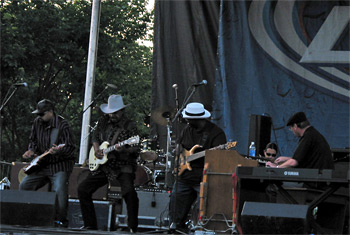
[241,202,308,234]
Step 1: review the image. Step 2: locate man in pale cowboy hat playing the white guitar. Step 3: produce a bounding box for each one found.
[78,95,139,232]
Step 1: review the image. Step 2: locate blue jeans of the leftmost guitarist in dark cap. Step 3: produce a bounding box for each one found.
[19,171,70,222]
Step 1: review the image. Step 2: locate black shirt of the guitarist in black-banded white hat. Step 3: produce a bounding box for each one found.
[179,120,226,185]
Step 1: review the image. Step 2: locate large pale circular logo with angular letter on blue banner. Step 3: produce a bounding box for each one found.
[248,0,350,98]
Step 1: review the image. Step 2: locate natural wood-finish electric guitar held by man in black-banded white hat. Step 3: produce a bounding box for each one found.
[175,141,237,175]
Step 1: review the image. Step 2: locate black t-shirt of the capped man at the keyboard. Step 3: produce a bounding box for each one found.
[293,126,334,170]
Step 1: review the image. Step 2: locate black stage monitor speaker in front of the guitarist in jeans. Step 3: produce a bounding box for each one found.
[0,190,56,226]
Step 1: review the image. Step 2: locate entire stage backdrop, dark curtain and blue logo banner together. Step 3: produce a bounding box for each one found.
[152,0,350,155]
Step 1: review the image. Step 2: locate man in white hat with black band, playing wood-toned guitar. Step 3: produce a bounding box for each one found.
[169,103,226,233]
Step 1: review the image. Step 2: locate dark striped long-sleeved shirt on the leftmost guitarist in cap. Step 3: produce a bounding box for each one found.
[28,114,75,174]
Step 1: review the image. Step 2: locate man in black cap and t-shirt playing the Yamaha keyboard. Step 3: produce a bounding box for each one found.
[266,112,334,169]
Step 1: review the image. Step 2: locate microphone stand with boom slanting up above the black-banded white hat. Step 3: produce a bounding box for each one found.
[168,86,200,231]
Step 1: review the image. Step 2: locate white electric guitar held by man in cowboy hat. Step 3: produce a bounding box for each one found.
[89,136,140,171]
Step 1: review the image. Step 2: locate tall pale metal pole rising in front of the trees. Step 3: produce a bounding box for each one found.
[79,0,101,164]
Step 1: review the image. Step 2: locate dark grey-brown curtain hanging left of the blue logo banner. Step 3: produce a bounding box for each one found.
[151,0,220,146]
